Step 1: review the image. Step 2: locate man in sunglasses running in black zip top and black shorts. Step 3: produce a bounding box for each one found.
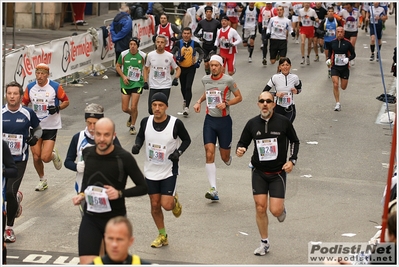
[236,92,299,256]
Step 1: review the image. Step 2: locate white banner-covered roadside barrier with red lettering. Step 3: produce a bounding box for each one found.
[4,15,155,87]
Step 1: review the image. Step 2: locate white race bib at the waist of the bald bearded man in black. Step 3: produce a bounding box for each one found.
[85,185,111,213]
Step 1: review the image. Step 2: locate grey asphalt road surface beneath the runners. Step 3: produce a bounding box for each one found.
[4,17,397,265]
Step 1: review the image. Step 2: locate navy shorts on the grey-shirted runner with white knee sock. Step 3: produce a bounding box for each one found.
[203,114,233,149]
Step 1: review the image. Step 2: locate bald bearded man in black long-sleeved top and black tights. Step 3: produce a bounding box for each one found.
[72,118,147,264]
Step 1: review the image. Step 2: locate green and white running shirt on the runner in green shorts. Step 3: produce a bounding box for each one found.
[118,49,146,89]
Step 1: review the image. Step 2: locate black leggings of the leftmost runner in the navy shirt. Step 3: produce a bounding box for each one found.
[6,161,28,226]
